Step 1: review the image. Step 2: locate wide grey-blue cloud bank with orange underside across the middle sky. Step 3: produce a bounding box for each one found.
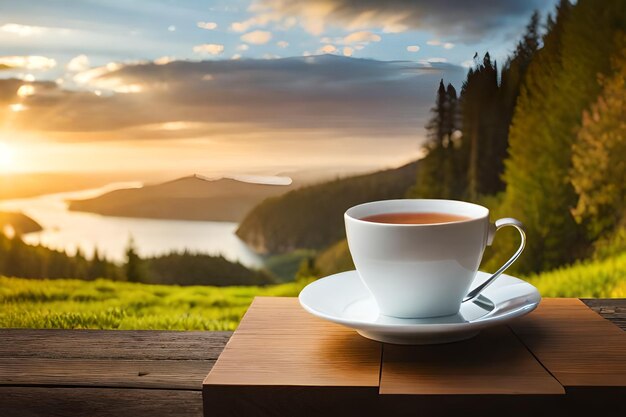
[0,51,465,139]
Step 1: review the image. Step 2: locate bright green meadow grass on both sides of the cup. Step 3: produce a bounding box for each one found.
[0,249,626,330]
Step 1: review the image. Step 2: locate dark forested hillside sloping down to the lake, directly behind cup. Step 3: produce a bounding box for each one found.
[237,162,418,253]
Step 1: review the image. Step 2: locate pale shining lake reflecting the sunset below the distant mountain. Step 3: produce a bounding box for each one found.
[0,182,263,267]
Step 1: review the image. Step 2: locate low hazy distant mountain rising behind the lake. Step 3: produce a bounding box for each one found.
[70,175,293,222]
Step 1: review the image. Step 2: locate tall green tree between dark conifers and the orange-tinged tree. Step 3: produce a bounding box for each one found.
[498,0,626,271]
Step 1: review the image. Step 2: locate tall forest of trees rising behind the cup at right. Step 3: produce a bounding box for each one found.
[409,0,626,272]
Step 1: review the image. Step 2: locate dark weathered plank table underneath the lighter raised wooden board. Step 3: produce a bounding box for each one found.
[0,299,626,417]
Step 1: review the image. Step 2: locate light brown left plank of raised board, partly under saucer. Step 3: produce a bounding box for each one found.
[204,297,381,391]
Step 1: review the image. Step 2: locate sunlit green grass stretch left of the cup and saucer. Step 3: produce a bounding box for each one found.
[0,277,306,330]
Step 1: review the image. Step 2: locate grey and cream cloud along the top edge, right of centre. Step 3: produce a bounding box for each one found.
[251,0,544,42]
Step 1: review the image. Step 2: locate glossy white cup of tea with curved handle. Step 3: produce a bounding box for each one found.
[344,199,526,318]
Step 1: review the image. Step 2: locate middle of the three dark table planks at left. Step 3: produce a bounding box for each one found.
[0,358,215,390]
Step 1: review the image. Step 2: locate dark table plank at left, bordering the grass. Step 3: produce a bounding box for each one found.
[0,329,232,360]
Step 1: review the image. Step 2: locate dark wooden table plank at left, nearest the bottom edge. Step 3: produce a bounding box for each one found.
[0,386,201,417]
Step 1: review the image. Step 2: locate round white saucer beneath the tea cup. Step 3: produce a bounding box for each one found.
[299,271,541,345]
